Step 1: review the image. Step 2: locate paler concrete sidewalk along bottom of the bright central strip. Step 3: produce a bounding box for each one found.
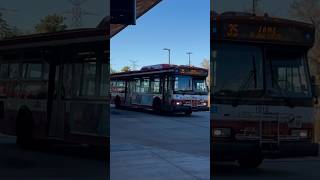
[110,144,210,180]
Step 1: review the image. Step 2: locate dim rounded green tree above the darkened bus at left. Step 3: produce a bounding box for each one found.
[35,14,67,33]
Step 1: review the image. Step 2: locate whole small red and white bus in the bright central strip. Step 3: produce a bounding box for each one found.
[111,64,209,115]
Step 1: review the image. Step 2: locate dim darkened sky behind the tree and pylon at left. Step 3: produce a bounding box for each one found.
[0,0,109,31]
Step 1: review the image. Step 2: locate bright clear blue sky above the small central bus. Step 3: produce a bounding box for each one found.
[110,0,210,70]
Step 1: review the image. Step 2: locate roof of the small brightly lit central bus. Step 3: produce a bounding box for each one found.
[111,64,208,78]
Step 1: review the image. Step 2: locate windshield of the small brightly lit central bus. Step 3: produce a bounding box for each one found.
[174,76,208,93]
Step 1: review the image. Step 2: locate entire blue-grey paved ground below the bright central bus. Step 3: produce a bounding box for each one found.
[110,108,210,180]
